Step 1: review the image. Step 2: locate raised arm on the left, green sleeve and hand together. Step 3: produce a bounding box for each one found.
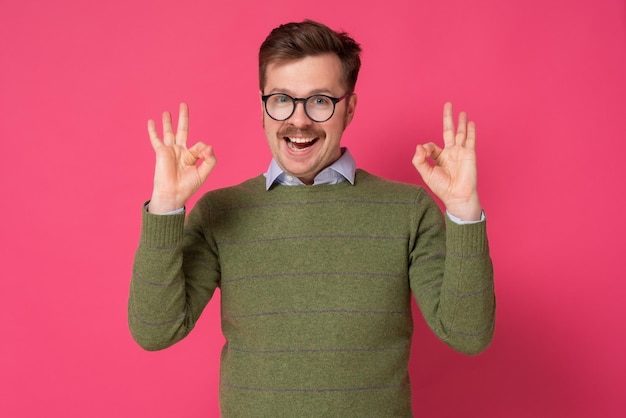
[128,104,219,350]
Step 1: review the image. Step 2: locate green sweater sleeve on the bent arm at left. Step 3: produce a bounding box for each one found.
[128,198,219,351]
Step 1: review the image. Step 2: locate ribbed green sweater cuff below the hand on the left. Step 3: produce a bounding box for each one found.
[139,205,185,248]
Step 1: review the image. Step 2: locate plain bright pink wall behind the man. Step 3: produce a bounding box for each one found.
[0,0,626,417]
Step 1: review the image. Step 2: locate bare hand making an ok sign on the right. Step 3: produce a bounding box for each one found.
[413,103,482,221]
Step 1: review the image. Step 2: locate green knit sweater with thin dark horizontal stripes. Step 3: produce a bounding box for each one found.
[129,170,495,418]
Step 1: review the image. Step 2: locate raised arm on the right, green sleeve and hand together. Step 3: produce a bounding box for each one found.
[411,103,495,354]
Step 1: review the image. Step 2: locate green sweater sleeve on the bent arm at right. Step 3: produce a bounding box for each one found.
[410,192,495,354]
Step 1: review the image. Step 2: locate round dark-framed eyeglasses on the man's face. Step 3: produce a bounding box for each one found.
[261,93,351,123]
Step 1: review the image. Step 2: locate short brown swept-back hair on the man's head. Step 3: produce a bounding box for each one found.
[259,20,361,93]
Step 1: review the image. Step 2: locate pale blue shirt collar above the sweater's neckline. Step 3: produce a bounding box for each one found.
[264,148,356,190]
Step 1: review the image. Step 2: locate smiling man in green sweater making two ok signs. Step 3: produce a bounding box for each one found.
[129,21,495,417]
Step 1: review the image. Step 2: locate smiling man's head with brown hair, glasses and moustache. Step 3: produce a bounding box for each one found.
[259,21,361,184]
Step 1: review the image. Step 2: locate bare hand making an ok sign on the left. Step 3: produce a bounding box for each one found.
[148,103,217,214]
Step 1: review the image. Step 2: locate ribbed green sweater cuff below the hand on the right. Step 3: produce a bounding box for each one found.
[446,217,489,257]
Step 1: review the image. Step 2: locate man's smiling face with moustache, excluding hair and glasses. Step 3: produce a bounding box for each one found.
[261,54,356,184]
